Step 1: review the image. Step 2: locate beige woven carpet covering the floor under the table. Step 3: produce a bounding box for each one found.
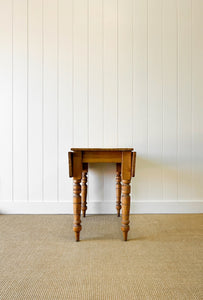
[0,215,203,300]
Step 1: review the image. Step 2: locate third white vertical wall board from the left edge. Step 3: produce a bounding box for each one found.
[28,0,43,201]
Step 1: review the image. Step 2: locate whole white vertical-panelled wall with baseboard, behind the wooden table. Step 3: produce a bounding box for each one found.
[0,0,203,213]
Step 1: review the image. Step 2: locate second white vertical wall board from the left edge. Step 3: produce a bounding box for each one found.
[13,0,28,201]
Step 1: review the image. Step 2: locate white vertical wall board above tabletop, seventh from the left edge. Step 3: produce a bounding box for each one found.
[88,0,103,147]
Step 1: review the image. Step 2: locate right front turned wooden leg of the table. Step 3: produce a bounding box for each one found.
[121,180,130,241]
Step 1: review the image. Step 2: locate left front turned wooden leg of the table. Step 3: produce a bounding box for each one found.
[73,178,82,242]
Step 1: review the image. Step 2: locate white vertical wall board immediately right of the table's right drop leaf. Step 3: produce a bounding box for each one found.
[131,0,148,200]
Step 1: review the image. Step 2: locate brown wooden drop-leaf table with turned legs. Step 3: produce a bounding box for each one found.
[68,148,136,241]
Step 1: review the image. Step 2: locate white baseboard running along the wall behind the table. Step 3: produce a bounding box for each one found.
[0,201,203,214]
